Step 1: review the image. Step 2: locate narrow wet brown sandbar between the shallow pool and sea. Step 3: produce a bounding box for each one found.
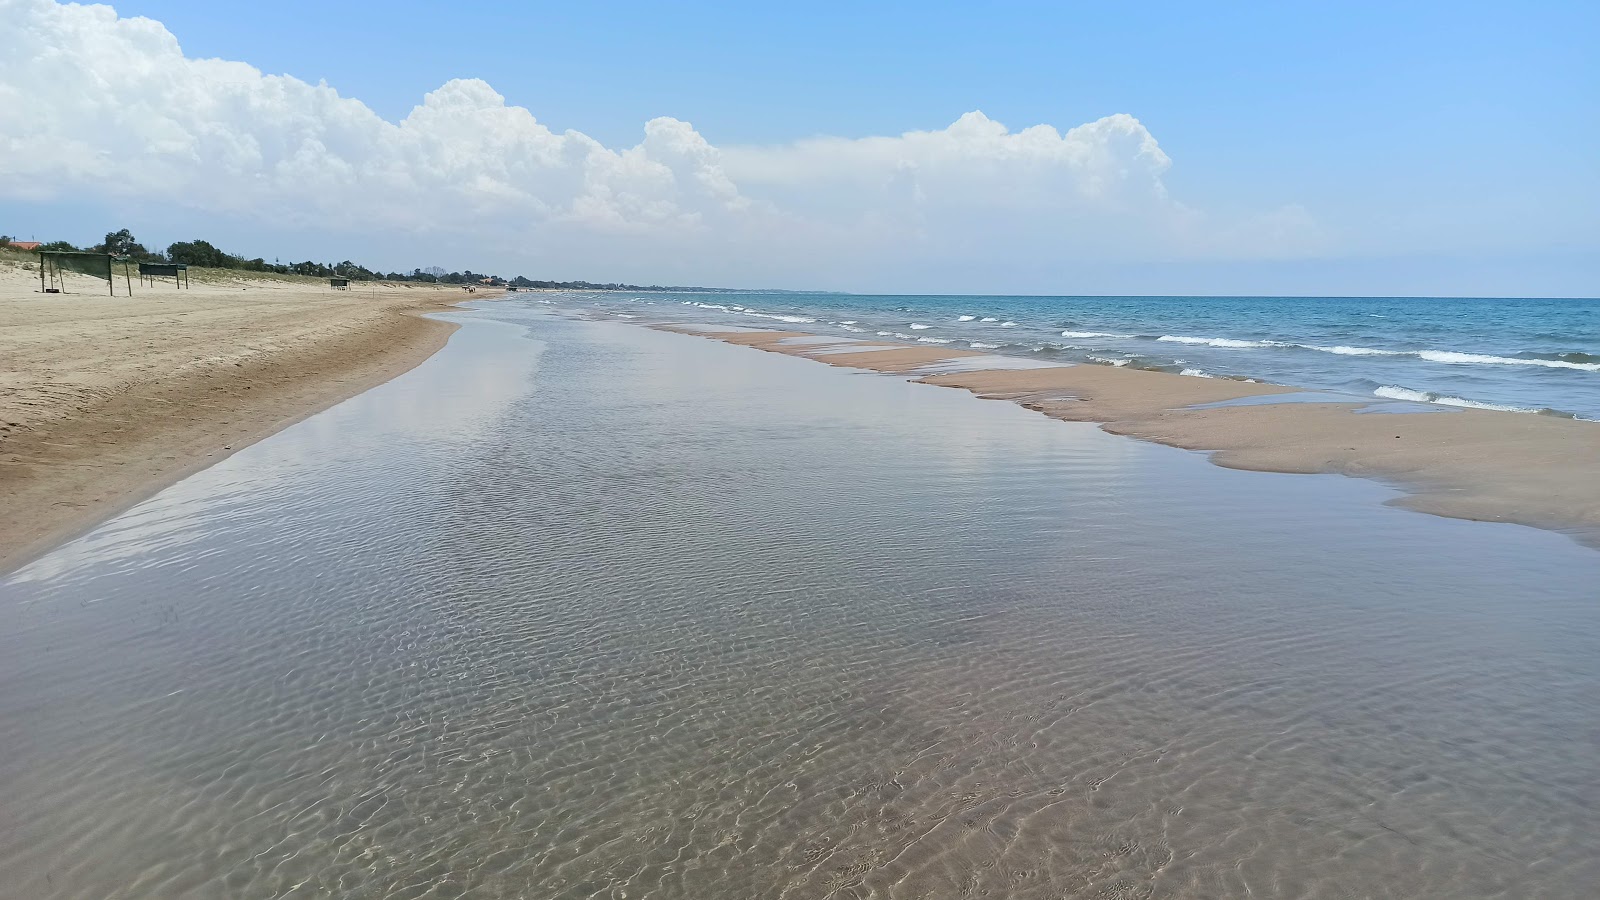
[658,325,1600,546]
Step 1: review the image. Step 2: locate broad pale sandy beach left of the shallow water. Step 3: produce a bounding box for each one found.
[0,258,485,572]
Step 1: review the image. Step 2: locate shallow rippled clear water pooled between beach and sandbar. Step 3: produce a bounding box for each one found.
[9,303,1600,898]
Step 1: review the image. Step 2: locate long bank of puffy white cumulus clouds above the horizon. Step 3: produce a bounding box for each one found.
[0,0,1317,283]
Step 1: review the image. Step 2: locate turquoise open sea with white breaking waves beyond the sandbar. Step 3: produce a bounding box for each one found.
[554,293,1600,420]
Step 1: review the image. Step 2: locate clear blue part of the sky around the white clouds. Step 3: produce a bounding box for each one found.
[9,0,1600,296]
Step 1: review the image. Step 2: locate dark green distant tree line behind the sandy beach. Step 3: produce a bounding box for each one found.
[0,229,718,291]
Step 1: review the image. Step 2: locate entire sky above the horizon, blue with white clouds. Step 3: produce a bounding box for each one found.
[0,0,1600,296]
